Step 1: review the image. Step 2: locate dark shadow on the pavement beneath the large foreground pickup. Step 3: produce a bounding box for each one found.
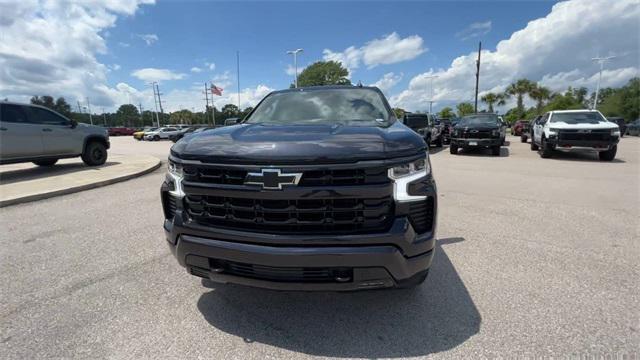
[198,238,481,358]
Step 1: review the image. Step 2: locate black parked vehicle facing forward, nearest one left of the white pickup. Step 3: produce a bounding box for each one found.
[449,113,507,156]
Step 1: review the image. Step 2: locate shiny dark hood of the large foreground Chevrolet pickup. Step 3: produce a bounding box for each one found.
[171,121,426,164]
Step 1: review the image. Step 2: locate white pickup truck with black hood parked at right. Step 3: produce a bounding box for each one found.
[531,110,620,161]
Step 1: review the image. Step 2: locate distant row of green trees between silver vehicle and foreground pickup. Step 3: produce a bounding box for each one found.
[30,95,253,127]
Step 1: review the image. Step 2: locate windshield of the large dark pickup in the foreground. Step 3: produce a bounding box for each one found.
[246,89,389,126]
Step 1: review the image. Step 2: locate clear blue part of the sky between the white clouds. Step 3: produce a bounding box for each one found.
[98,1,554,101]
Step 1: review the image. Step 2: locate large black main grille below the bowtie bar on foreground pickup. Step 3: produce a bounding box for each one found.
[184,195,393,234]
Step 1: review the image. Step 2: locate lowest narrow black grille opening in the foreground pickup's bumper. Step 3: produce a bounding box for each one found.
[211,259,353,283]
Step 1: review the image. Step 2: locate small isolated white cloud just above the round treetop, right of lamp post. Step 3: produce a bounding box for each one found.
[322,32,427,73]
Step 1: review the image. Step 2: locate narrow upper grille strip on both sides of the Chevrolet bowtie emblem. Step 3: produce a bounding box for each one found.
[184,166,390,186]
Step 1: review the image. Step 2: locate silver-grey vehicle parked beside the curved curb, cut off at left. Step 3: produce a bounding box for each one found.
[0,102,109,166]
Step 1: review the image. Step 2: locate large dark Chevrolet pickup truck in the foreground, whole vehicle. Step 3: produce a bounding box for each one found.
[161,86,437,291]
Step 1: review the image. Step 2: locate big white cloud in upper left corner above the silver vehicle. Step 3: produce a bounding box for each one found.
[0,0,152,107]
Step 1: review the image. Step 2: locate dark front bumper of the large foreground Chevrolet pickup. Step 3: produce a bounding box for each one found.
[162,173,437,291]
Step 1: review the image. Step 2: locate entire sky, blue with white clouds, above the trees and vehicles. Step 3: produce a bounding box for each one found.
[0,0,640,111]
